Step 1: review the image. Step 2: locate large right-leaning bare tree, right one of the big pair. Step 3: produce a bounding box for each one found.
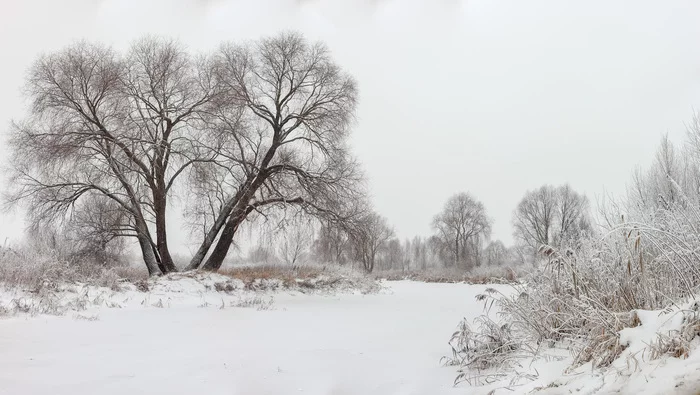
[188,33,361,270]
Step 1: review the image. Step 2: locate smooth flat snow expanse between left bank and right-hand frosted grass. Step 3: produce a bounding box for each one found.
[0,282,506,395]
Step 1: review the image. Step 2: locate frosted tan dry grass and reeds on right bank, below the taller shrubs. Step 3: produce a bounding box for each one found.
[446,220,700,390]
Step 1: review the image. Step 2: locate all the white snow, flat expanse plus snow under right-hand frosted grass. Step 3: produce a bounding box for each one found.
[0,275,700,395]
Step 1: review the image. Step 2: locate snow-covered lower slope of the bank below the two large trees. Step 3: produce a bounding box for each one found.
[0,272,382,315]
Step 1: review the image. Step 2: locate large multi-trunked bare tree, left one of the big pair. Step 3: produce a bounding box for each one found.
[10,39,217,275]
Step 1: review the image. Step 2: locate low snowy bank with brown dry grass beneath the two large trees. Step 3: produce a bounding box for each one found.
[0,253,381,316]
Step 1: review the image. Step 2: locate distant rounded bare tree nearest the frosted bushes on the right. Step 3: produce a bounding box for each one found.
[513,185,591,255]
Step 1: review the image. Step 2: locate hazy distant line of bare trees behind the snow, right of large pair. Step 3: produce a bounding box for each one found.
[239,185,593,272]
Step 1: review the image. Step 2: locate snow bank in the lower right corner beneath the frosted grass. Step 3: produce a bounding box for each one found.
[468,302,700,395]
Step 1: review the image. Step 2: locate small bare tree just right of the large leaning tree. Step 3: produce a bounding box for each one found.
[350,212,394,273]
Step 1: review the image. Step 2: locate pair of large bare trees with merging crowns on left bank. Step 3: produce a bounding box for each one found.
[10,33,363,275]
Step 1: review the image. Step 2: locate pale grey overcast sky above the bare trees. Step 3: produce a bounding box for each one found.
[0,0,700,251]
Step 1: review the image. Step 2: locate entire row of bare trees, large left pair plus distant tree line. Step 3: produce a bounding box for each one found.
[5,32,688,275]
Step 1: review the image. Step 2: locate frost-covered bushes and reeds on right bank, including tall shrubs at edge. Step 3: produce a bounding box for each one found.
[448,130,700,386]
